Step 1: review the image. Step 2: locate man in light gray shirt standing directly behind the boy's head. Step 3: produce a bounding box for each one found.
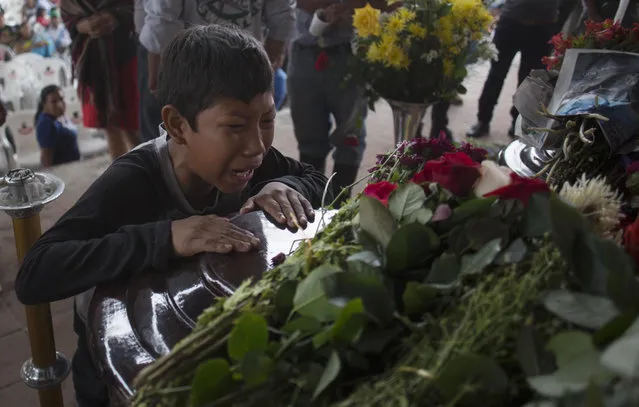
[138,0,295,124]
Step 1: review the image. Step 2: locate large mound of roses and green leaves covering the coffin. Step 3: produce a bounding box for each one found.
[132,140,639,407]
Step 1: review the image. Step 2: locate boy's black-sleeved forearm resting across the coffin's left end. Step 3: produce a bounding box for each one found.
[15,220,172,305]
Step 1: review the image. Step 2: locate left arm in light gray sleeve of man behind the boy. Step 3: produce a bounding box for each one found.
[140,0,184,91]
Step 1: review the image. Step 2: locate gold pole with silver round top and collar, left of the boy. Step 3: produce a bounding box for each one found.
[0,169,71,407]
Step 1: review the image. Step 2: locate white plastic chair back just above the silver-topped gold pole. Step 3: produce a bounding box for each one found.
[7,110,41,169]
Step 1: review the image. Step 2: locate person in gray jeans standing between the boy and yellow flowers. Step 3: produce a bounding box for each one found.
[287,0,386,205]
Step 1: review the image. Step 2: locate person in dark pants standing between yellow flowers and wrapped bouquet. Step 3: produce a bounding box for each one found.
[466,0,559,138]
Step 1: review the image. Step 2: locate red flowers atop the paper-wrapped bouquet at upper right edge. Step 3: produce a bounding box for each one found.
[543,19,639,70]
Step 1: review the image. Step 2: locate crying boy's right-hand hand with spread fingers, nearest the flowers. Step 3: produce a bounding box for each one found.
[240,182,315,229]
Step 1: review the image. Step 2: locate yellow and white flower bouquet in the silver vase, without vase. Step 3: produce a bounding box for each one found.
[353,0,492,103]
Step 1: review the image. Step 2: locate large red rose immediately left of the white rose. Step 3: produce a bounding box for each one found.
[412,152,480,197]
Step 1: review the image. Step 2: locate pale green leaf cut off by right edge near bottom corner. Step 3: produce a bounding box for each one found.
[601,319,639,379]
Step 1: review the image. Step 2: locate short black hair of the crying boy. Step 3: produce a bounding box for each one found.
[157,24,273,131]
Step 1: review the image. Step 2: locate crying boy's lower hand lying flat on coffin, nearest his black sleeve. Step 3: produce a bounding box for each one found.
[171,215,260,257]
